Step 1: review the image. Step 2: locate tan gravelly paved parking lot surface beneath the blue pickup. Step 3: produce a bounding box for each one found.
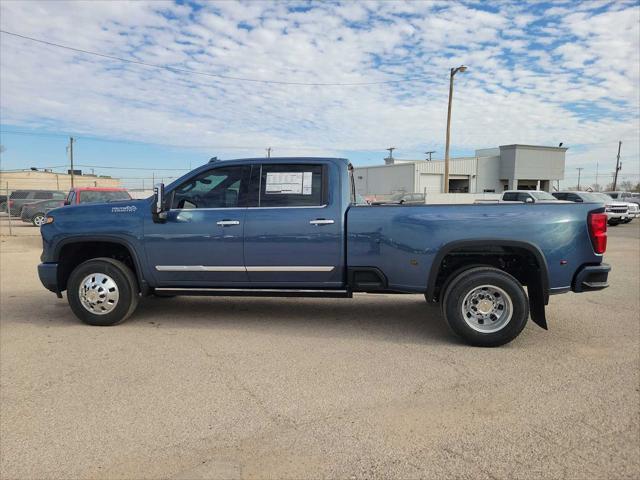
[0,220,640,479]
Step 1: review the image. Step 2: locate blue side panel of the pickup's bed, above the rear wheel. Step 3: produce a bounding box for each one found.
[347,202,604,293]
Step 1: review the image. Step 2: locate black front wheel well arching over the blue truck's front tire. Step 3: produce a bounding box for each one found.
[58,241,139,291]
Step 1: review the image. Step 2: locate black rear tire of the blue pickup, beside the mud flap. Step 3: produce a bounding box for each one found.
[442,267,529,347]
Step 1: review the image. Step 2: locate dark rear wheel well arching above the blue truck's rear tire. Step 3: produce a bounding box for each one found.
[432,245,546,300]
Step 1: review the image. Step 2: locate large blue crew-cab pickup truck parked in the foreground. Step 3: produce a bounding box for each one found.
[38,158,610,346]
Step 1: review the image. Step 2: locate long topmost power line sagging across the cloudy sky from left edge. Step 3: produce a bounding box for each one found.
[0,30,425,87]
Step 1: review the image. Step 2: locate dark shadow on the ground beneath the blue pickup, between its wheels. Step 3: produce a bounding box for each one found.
[130,295,461,345]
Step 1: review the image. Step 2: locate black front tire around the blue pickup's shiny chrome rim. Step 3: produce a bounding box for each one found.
[67,257,138,327]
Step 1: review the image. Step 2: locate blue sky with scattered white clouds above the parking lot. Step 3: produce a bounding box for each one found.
[0,0,640,191]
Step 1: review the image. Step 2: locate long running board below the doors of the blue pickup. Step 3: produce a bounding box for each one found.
[155,287,353,298]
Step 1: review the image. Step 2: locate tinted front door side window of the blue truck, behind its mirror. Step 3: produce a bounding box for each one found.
[171,166,251,209]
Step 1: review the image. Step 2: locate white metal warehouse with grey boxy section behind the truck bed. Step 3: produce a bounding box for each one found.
[355,145,567,196]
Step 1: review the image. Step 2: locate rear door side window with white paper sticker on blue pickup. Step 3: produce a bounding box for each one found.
[260,164,326,207]
